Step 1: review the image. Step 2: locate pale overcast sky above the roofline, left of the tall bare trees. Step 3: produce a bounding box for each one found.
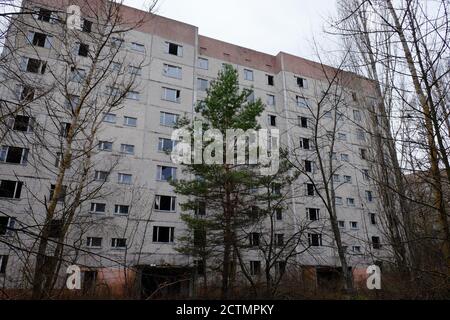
[125,0,336,60]
